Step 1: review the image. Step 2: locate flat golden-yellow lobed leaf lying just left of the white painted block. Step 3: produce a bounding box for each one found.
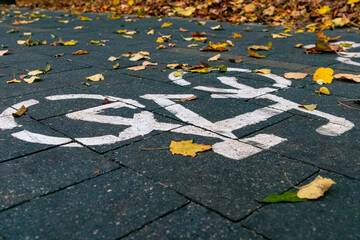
[169,140,212,157]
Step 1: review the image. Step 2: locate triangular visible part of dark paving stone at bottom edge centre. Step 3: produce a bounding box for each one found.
[124,203,263,240]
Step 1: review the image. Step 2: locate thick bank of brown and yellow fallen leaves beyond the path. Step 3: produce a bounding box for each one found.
[7,0,360,29]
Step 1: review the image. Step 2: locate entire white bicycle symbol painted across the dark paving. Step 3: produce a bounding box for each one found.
[0,68,354,160]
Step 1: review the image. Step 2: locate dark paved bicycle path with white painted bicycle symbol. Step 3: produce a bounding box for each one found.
[0,9,360,239]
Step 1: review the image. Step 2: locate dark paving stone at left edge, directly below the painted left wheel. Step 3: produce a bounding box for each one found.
[0,147,118,210]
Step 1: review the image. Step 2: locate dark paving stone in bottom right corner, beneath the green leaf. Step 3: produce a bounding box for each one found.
[242,171,360,239]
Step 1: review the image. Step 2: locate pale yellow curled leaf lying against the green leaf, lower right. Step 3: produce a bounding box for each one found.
[297,175,336,199]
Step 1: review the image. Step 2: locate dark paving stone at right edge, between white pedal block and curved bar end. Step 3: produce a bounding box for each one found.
[242,116,360,178]
